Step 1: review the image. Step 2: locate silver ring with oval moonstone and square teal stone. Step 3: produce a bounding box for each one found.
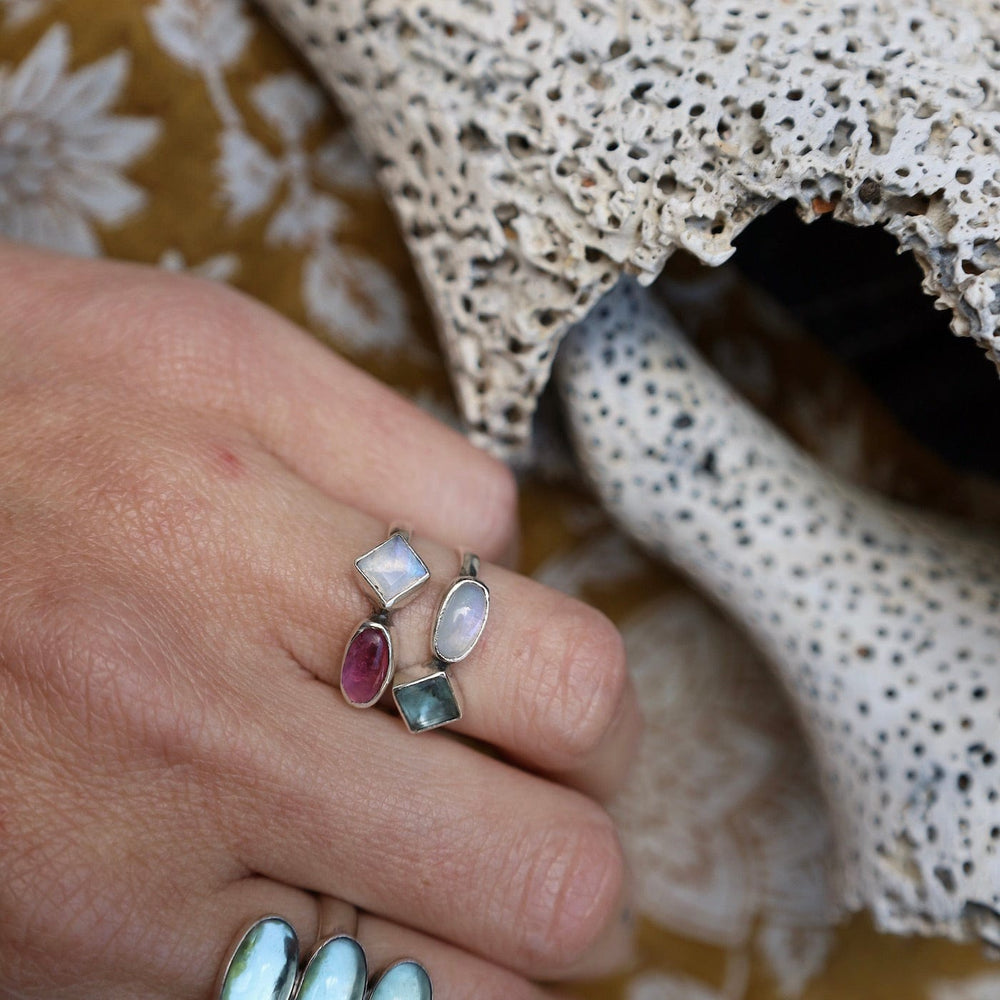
[392,552,490,733]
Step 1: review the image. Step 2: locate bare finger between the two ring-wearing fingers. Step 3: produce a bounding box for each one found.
[218,674,624,976]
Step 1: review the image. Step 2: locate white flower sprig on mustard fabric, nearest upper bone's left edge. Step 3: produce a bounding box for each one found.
[149,0,418,363]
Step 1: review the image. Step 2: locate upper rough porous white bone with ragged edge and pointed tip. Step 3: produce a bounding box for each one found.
[262,0,1000,450]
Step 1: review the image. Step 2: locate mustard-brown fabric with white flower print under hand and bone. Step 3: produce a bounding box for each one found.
[0,0,1000,1000]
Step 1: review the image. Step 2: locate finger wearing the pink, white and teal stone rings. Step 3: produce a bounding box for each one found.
[233,458,640,797]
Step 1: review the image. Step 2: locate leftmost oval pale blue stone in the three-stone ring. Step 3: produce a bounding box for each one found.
[219,917,299,1000]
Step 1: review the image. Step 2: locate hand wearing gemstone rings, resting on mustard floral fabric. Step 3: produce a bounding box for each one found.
[0,246,638,1000]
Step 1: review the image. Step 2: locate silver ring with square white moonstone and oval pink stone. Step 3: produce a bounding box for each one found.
[340,525,431,708]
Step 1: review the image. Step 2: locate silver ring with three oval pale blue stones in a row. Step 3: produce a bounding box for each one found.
[218,916,433,1000]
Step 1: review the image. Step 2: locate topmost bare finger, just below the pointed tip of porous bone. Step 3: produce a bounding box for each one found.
[153,266,518,558]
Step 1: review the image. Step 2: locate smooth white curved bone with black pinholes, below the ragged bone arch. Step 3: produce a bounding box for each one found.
[557,279,1000,943]
